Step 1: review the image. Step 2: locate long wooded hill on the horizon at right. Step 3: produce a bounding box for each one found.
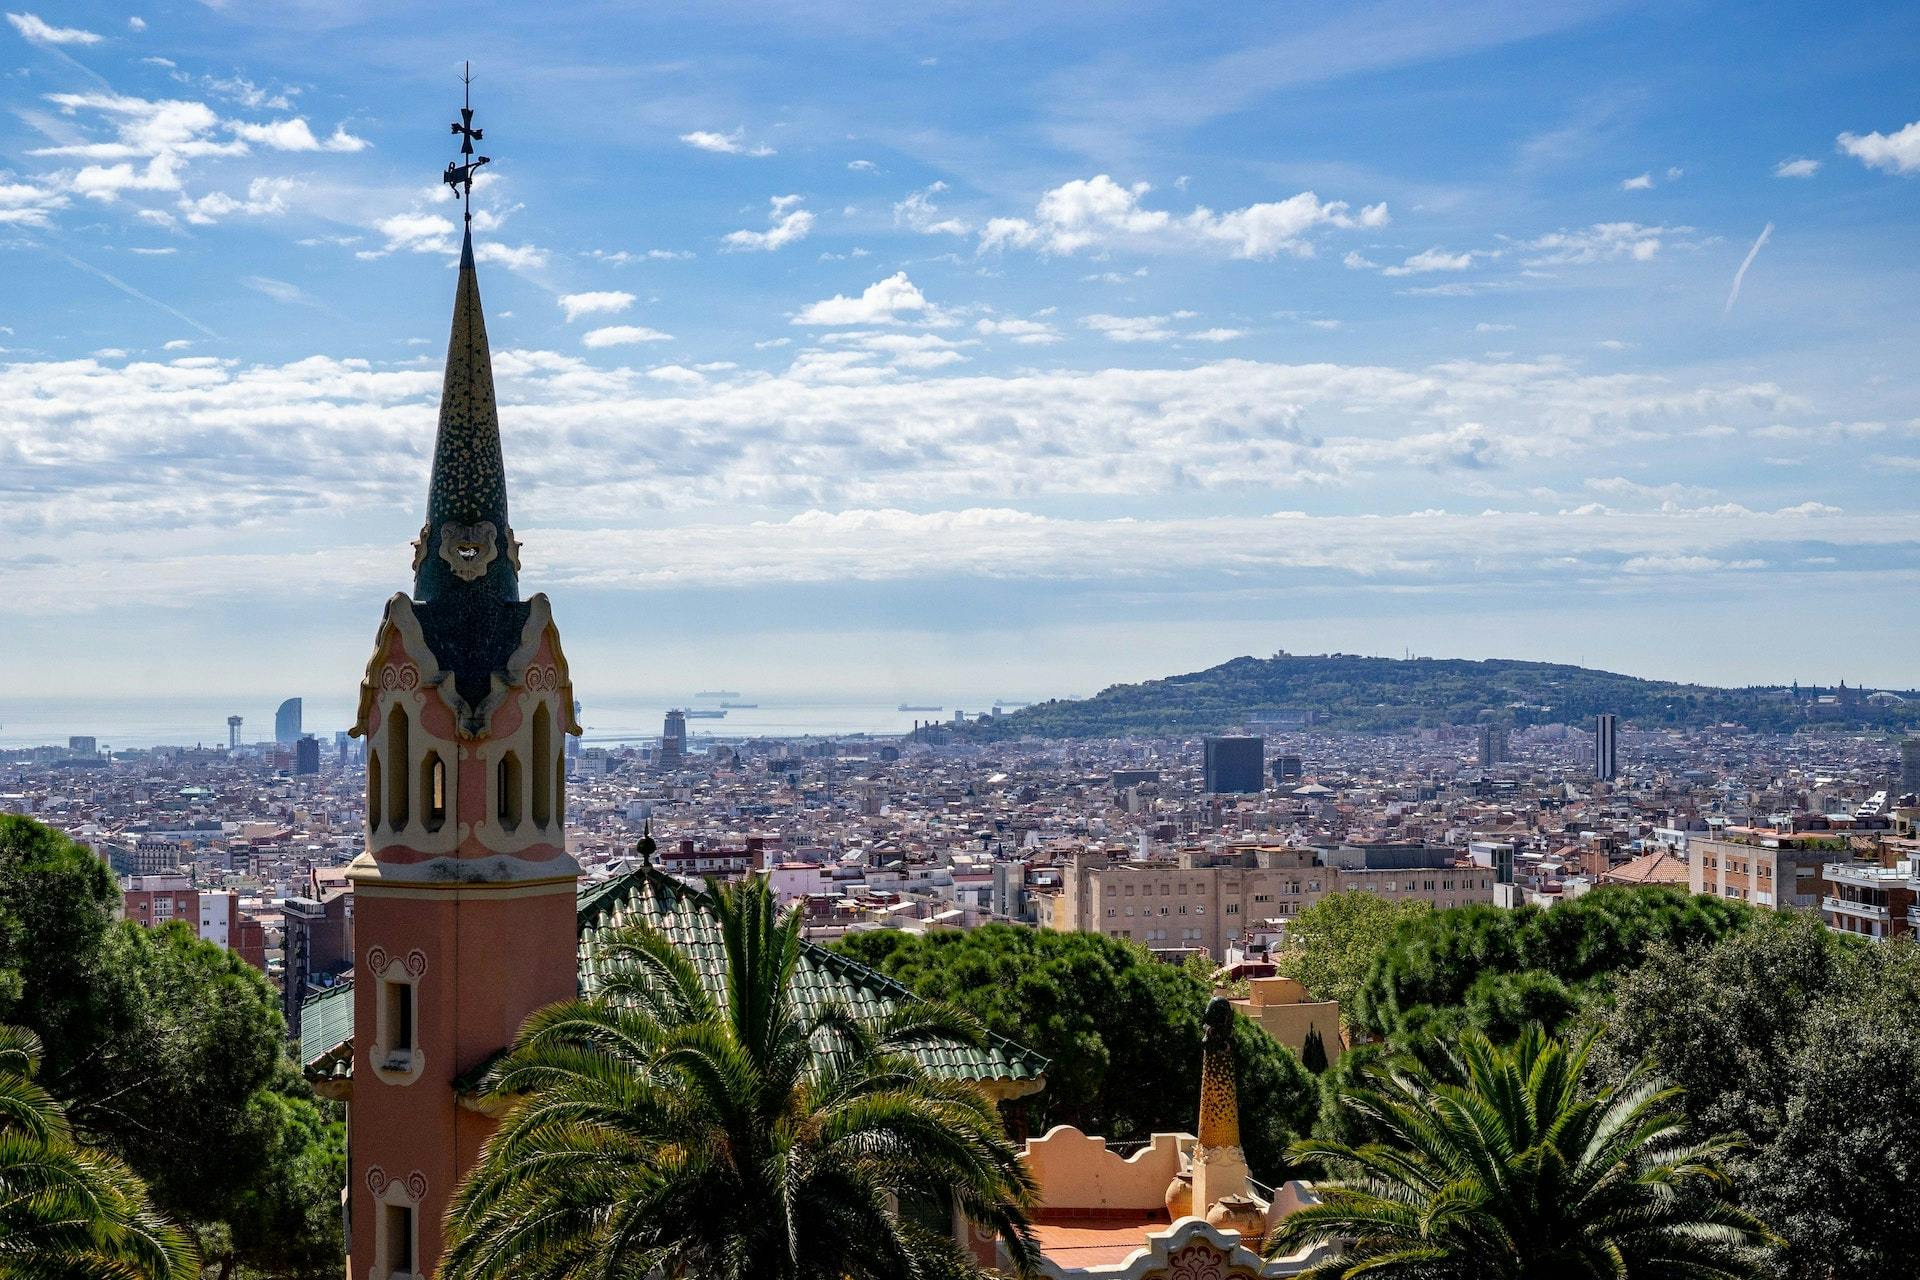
[970,652,1920,739]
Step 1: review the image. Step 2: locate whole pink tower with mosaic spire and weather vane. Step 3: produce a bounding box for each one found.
[348,84,580,1280]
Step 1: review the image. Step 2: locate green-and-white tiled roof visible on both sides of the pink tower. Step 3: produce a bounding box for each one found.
[300,869,1046,1092]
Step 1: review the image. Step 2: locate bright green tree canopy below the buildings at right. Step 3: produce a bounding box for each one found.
[1348,887,1753,1048]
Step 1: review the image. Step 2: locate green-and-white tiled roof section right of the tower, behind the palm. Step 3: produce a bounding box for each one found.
[580,869,1046,1086]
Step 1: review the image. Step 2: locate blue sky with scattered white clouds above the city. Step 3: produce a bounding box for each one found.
[0,0,1920,710]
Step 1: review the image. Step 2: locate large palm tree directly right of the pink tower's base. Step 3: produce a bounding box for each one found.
[442,885,1037,1280]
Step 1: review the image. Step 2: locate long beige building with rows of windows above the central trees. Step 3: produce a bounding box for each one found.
[1039,844,1494,958]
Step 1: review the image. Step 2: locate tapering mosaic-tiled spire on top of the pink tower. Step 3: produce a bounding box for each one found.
[413,230,520,601]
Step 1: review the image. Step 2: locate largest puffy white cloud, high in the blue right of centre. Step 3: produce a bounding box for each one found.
[979,173,1388,259]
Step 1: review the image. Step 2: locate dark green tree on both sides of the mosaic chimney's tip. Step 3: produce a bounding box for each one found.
[835,925,1319,1182]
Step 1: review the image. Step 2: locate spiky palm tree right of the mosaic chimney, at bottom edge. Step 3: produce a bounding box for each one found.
[1267,1027,1780,1280]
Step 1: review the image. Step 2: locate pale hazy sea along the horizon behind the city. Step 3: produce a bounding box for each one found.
[0,691,1018,748]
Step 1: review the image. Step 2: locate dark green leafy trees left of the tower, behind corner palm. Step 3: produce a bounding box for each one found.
[0,818,346,1276]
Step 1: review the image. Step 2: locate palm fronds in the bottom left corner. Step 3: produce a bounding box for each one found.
[0,1027,200,1280]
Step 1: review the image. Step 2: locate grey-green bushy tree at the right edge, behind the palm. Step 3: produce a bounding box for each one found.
[1596,913,1920,1280]
